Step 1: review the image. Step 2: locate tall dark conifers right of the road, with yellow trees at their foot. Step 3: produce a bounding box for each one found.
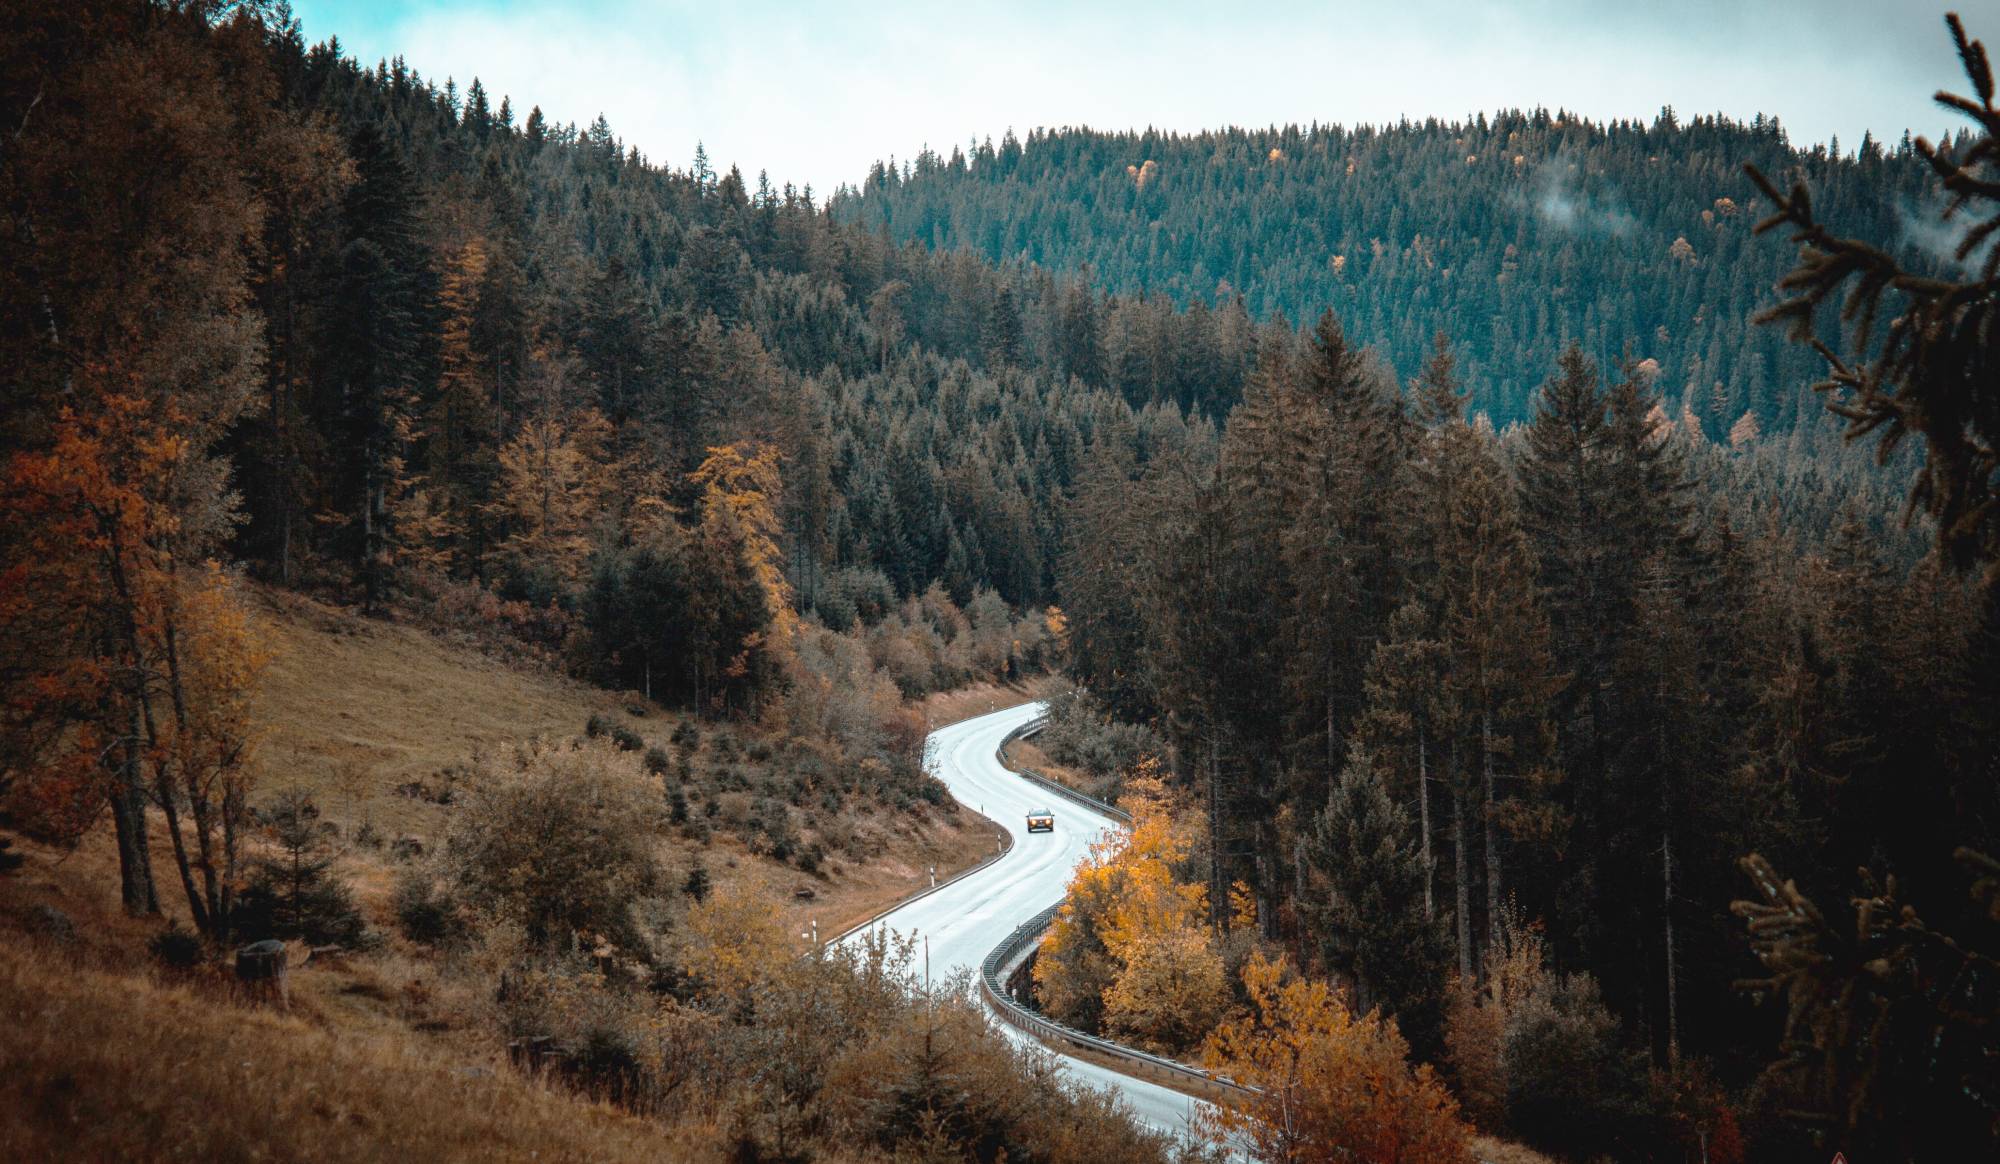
[1032,42,2000,1160]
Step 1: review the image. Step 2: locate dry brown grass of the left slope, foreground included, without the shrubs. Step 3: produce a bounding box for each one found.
[0,592,1028,1160]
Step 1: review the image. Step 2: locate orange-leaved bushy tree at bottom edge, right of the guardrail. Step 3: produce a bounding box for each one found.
[1200,956,1470,1164]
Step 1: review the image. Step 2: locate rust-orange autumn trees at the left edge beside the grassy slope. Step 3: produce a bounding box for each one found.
[0,392,266,932]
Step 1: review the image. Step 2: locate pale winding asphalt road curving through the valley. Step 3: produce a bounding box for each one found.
[836,704,1200,1136]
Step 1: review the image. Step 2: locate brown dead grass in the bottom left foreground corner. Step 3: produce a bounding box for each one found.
[0,942,688,1162]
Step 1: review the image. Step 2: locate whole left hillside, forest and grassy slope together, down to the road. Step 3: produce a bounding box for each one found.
[0,0,1184,1160]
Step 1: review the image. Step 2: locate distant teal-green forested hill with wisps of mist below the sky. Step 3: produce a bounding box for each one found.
[834,110,1946,440]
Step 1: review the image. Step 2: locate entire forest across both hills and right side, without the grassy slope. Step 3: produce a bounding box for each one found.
[0,0,2000,1160]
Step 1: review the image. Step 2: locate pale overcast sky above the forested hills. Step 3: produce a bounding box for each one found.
[292,0,2000,194]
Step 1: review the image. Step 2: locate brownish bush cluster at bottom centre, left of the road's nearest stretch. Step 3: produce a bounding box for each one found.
[502,928,1168,1162]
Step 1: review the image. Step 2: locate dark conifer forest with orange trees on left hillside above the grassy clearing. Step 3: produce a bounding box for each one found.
[0,2,1254,708]
